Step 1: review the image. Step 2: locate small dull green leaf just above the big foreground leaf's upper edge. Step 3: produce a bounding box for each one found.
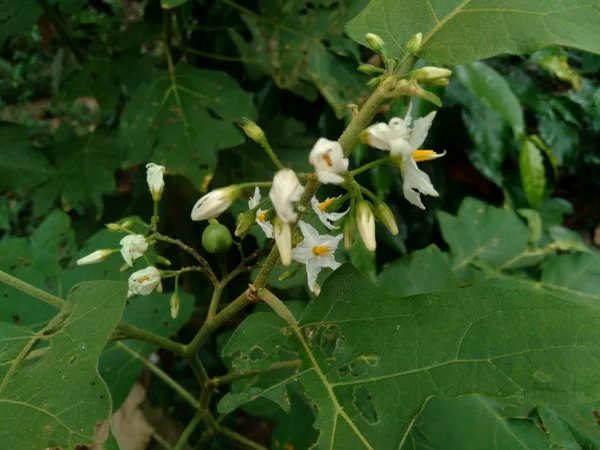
[377,245,458,297]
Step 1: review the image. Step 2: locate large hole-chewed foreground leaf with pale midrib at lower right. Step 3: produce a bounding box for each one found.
[219,265,600,450]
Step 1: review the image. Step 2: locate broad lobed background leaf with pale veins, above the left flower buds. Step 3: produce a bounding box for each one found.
[121,64,256,187]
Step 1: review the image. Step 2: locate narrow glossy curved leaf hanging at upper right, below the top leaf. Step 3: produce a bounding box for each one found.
[455,62,525,138]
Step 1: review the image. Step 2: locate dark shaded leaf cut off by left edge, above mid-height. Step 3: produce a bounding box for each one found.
[0,124,56,191]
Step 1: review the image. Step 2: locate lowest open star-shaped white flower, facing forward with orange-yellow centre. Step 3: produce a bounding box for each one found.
[292,220,343,293]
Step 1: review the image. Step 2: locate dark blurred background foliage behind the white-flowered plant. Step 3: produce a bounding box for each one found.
[0,0,600,448]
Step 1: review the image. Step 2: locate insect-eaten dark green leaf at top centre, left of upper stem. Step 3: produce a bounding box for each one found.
[232,0,368,117]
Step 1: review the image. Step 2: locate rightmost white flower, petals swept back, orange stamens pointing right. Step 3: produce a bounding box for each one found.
[366,105,445,209]
